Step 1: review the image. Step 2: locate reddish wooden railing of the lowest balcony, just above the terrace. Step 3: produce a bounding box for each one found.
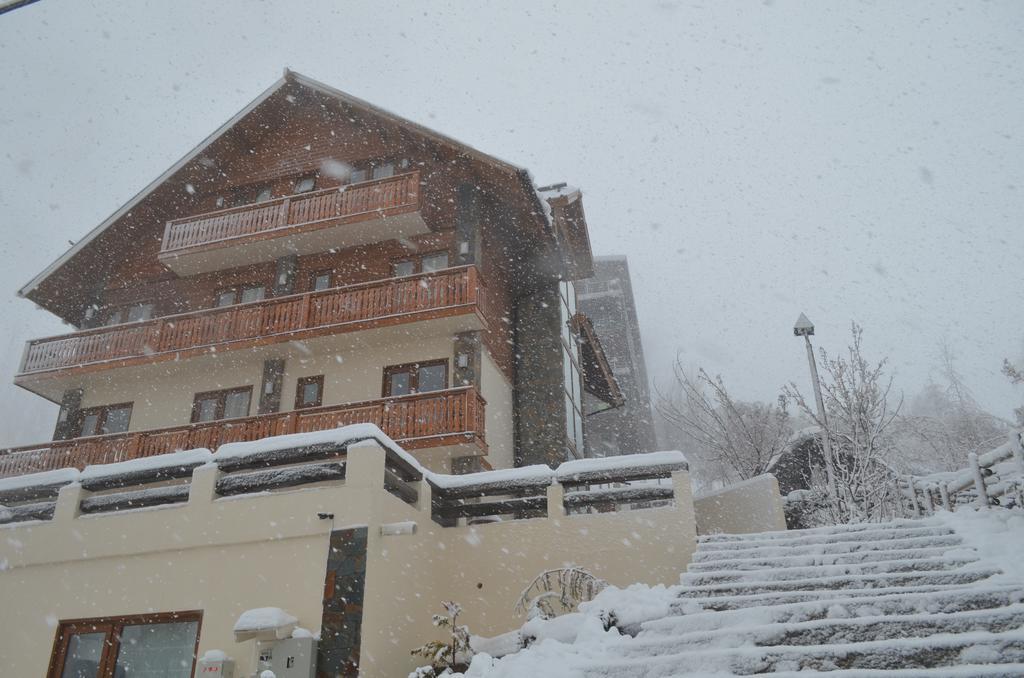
[0,386,486,477]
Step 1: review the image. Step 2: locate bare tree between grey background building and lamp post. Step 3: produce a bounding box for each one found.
[657,358,793,483]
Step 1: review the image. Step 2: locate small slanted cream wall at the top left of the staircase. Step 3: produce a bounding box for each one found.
[693,474,785,535]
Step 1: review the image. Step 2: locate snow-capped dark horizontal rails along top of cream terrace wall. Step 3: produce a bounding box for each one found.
[0,424,687,526]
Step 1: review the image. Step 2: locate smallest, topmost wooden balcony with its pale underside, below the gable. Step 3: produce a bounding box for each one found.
[159,172,428,276]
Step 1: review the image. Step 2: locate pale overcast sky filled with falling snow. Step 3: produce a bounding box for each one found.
[0,0,1024,446]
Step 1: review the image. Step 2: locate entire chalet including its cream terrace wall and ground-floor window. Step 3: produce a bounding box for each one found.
[0,72,784,678]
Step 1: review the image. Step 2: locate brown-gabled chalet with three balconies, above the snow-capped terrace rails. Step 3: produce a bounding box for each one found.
[0,72,620,476]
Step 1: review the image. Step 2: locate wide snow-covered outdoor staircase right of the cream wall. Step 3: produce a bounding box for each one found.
[584,520,1024,678]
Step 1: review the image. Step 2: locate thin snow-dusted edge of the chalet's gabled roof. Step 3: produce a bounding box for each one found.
[17,69,550,297]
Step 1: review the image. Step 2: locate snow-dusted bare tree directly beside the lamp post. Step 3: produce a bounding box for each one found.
[783,323,903,522]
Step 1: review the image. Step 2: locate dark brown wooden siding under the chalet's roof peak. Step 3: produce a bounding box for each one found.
[27,81,550,325]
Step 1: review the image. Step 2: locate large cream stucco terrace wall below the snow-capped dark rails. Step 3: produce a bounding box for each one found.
[0,442,695,677]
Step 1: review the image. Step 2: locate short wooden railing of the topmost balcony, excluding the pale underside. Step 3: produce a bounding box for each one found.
[160,172,420,255]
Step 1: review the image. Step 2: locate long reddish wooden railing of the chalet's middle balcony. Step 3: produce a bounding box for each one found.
[19,266,481,376]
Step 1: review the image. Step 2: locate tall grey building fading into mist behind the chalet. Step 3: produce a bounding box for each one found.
[577,256,657,457]
